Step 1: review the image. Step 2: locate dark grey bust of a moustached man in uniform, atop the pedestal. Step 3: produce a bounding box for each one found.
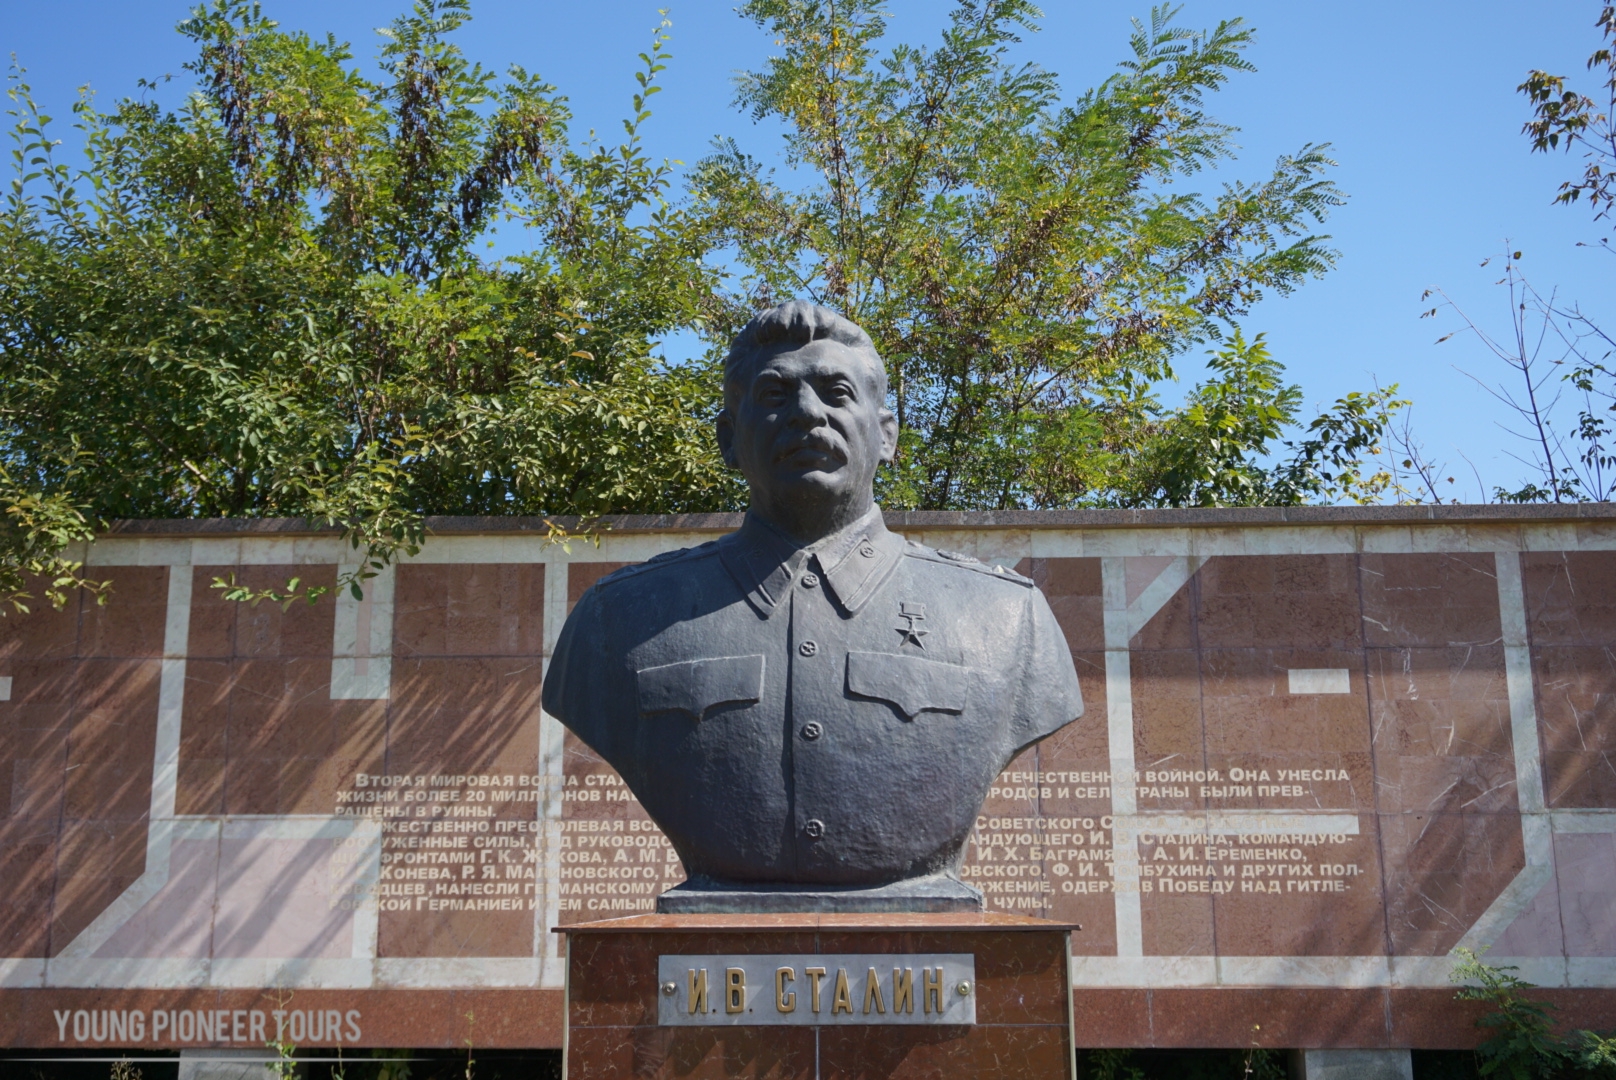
[545,302,1083,912]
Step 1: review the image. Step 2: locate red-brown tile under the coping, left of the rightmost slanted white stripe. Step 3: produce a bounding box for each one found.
[1359,553,1503,648]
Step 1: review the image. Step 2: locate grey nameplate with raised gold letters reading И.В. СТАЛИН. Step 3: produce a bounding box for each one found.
[656,952,976,1027]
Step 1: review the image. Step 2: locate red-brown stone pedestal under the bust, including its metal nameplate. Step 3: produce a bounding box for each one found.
[556,913,1075,1080]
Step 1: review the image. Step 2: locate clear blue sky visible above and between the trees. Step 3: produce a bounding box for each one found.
[0,0,1616,501]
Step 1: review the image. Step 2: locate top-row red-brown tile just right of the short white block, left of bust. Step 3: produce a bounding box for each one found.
[393,563,545,656]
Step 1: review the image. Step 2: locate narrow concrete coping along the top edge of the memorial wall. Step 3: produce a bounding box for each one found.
[103,503,1616,537]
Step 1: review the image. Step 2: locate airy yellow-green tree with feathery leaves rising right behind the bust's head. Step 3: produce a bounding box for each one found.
[692,0,1396,509]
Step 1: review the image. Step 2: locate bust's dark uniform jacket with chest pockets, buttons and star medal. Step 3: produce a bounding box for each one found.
[545,508,1083,886]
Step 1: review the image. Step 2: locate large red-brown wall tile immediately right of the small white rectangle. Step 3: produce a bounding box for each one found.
[1369,645,1517,813]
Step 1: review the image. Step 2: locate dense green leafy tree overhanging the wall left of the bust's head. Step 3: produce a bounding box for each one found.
[0,0,739,605]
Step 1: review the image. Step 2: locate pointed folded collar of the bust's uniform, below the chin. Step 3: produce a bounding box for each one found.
[719,506,903,618]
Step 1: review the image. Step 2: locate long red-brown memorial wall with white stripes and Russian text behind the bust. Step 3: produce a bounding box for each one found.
[0,506,1616,1048]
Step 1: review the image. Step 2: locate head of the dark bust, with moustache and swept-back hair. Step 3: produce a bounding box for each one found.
[718,301,898,543]
